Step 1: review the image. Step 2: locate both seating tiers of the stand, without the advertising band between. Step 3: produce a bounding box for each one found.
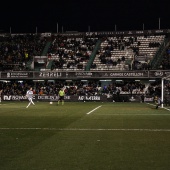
[0,29,170,101]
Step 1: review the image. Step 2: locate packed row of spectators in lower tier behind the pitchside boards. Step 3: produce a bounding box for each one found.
[0,80,163,96]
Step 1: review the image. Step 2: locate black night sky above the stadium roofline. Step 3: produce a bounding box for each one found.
[0,0,170,33]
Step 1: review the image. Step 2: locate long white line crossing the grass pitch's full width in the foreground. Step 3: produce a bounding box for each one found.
[0,128,170,132]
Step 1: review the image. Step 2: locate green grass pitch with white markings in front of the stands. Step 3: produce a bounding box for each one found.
[0,102,170,170]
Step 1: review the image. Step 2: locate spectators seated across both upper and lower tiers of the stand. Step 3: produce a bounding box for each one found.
[0,34,170,104]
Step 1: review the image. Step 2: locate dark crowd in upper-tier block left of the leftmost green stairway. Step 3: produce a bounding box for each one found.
[0,34,47,71]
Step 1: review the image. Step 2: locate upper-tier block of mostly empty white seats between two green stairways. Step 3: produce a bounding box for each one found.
[93,35,165,70]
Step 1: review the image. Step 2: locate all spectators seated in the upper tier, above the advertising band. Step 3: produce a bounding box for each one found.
[0,34,169,71]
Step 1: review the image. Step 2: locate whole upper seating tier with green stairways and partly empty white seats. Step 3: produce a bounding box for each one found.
[0,31,169,71]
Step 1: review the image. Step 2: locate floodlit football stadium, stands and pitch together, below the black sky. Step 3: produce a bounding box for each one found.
[0,29,170,170]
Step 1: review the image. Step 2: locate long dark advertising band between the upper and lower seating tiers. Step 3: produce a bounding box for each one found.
[0,70,170,80]
